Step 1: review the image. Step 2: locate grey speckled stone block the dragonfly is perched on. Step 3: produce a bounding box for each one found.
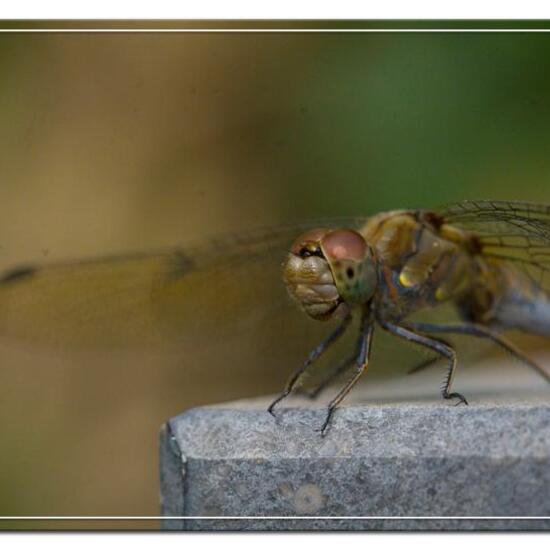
[161,364,550,530]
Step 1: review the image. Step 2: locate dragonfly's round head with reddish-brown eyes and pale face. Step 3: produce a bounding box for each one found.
[283,229,377,320]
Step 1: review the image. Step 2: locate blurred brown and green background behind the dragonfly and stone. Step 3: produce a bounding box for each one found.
[0,25,550,528]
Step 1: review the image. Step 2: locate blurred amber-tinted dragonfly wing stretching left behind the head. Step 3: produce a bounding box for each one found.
[0,220,366,350]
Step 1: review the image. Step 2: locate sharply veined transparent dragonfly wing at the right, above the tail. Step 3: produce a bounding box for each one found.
[439,200,550,290]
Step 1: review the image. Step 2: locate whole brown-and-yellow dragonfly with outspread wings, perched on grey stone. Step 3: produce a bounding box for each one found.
[0,200,550,435]
